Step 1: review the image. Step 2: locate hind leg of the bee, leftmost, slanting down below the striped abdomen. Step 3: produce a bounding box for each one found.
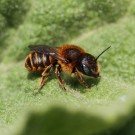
[33,64,52,92]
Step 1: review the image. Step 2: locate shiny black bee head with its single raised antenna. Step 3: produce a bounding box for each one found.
[76,46,111,78]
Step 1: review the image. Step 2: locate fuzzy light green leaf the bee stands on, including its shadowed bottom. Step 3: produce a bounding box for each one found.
[0,17,135,135]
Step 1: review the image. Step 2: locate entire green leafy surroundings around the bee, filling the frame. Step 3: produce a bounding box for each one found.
[0,0,135,135]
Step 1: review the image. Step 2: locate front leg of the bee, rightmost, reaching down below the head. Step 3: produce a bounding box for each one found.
[72,70,90,88]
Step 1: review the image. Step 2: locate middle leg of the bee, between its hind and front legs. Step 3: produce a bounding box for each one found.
[55,65,66,91]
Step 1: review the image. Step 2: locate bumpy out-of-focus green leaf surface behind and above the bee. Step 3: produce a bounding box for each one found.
[0,0,130,62]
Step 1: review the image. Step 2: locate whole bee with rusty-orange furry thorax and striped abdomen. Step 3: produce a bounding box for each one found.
[25,44,111,90]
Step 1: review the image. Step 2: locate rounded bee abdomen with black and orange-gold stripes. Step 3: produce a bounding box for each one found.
[25,52,52,71]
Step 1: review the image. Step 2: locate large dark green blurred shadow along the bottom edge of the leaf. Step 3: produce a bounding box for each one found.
[18,106,109,135]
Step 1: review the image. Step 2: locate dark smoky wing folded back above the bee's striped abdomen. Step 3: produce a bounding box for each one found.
[29,45,68,63]
